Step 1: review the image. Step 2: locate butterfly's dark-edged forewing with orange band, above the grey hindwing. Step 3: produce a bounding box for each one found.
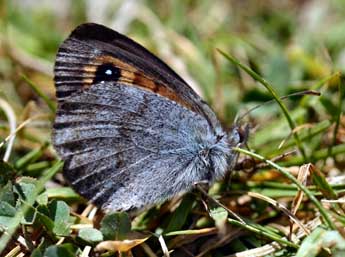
[55,23,219,130]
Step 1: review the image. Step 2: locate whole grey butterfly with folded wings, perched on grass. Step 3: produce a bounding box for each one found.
[52,23,243,212]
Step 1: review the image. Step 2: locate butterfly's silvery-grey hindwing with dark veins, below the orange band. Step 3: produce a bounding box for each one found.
[53,82,225,210]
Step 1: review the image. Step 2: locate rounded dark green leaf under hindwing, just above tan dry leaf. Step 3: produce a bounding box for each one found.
[101,212,131,240]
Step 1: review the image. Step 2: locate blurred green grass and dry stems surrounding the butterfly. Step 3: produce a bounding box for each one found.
[0,0,345,257]
